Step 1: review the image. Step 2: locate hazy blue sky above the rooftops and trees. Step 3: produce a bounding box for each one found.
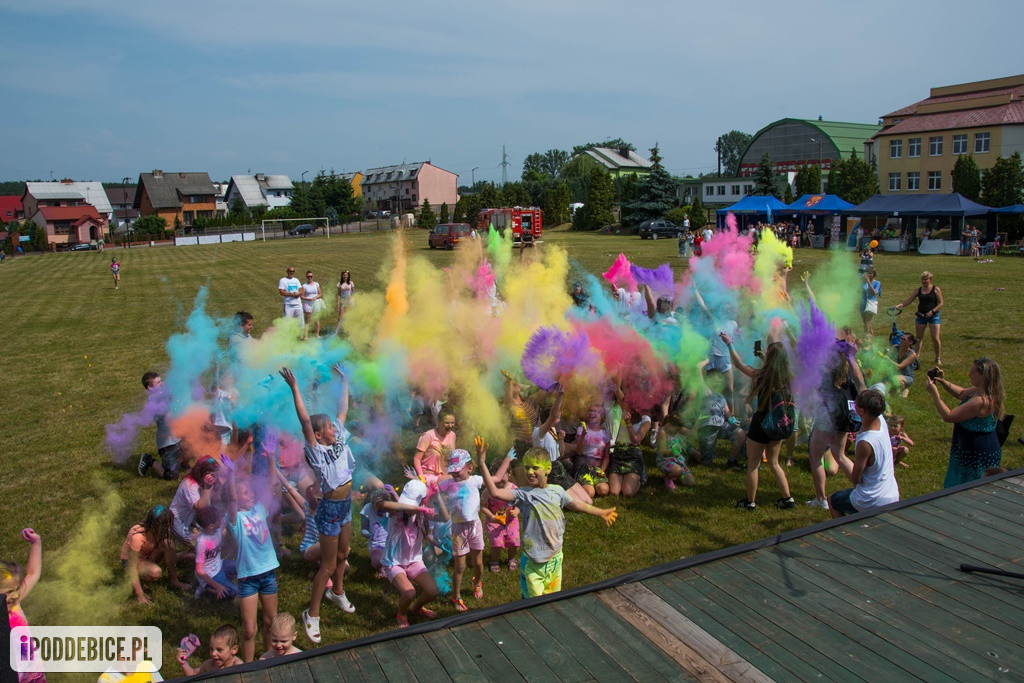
[0,0,1024,185]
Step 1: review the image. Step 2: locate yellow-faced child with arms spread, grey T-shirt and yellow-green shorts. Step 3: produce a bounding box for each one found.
[473,436,618,598]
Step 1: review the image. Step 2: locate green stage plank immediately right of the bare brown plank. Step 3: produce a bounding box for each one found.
[643,571,853,681]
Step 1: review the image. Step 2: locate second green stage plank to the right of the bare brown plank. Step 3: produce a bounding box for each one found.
[731,553,913,680]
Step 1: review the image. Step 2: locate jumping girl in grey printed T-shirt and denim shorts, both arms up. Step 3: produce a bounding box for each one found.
[281,366,355,643]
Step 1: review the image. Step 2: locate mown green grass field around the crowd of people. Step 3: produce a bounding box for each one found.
[0,225,1024,675]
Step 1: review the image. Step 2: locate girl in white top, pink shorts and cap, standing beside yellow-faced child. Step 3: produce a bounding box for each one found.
[444,449,483,612]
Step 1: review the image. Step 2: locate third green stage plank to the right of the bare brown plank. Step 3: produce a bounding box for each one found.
[762,545,990,681]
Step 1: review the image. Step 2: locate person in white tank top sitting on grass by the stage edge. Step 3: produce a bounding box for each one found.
[828,389,899,518]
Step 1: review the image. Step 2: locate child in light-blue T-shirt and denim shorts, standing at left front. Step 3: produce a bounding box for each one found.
[227,471,280,661]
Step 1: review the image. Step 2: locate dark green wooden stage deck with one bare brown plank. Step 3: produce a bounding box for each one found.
[188,470,1024,683]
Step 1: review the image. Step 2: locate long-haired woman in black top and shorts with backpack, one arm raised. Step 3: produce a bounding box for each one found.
[721,332,796,510]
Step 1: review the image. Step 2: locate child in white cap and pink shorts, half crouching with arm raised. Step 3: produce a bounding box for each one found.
[375,479,438,628]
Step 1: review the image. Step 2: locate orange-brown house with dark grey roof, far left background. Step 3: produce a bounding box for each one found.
[133,169,217,228]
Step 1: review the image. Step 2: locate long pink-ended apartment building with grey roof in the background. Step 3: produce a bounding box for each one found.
[360,161,459,214]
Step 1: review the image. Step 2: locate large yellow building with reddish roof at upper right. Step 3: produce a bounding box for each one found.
[866,75,1024,195]
